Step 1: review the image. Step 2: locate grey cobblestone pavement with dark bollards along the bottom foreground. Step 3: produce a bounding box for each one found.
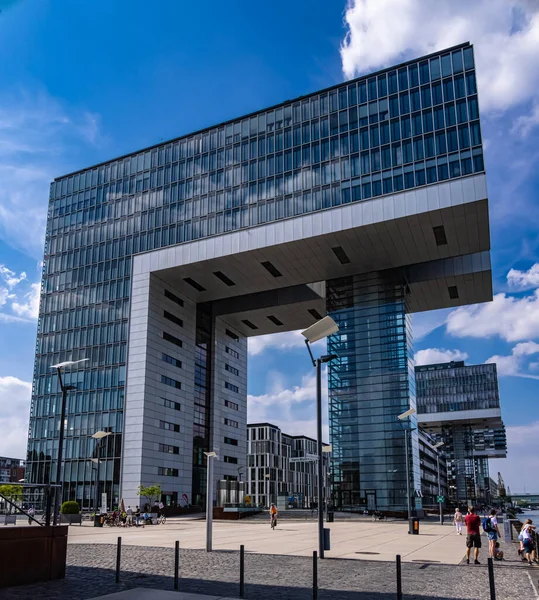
[0,544,539,600]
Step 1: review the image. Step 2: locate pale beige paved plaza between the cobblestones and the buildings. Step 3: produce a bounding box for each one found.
[69,519,472,565]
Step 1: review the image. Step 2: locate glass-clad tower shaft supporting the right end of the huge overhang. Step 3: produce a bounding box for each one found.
[326,272,420,511]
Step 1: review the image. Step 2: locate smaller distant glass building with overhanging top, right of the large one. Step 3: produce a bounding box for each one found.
[415,361,507,505]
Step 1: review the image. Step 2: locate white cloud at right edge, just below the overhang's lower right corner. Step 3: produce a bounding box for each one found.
[447,290,539,342]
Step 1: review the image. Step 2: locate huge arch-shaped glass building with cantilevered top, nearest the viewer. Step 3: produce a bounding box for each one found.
[28,44,492,509]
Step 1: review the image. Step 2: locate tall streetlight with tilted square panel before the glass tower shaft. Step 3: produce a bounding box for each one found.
[301,315,339,558]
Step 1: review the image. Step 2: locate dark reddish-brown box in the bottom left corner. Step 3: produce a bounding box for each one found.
[0,525,68,588]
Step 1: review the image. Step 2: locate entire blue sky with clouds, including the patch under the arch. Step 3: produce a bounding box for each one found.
[0,0,539,491]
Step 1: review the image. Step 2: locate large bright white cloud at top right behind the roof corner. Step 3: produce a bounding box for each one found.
[341,0,539,110]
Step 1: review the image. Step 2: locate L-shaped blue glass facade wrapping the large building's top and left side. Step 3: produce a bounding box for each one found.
[28,45,484,507]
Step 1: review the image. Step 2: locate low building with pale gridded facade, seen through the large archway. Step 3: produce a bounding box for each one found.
[246,423,329,508]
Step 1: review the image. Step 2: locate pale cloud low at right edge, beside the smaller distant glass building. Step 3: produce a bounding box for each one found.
[489,421,539,493]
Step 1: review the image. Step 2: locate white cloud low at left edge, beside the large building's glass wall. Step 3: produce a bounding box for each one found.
[0,376,32,458]
